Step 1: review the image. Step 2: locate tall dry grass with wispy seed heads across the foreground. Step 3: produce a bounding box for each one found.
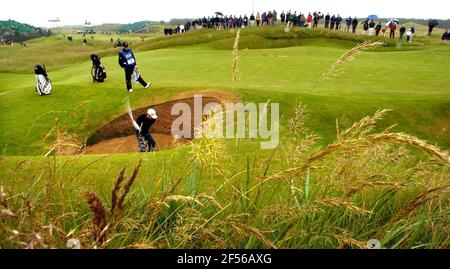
[0,105,450,248]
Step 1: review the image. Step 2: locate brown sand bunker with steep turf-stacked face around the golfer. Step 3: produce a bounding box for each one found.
[85,97,220,154]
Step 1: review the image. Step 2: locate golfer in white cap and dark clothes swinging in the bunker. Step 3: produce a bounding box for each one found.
[134,108,158,152]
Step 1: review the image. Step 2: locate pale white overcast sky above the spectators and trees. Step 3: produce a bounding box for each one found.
[0,0,450,27]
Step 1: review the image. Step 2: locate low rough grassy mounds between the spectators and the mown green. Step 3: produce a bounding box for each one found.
[0,24,440,72]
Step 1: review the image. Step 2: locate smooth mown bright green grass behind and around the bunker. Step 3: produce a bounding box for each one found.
[0,30,450,155]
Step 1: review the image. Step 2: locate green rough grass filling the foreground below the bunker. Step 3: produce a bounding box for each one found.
[0,118,449,249]
